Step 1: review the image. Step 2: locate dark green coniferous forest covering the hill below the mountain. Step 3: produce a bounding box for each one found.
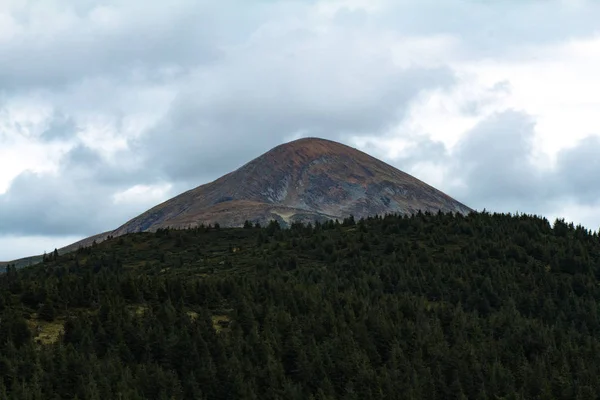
[0,212,600,400]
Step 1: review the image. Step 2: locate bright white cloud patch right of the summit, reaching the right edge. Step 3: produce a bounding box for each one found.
[376,32,600,189]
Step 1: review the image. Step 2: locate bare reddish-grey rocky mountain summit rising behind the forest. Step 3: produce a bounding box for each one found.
[113,138,472,236]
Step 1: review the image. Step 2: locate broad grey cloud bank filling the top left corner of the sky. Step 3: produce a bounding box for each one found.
[0,0,332,92]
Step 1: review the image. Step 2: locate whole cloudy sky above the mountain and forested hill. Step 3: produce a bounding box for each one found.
[0,0,600,260]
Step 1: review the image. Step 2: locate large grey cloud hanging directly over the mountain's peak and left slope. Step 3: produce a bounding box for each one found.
[137,44,454,180]
